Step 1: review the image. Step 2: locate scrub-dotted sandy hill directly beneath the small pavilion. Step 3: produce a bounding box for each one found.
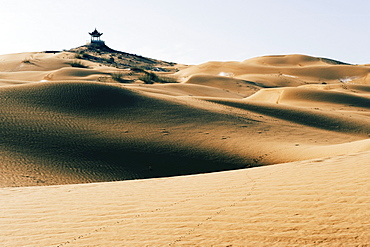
[0,43,186,84]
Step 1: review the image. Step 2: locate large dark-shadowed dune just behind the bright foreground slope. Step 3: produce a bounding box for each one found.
[0,82,368,186]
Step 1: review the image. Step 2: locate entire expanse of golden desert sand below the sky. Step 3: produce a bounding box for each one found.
[0,46,370,246]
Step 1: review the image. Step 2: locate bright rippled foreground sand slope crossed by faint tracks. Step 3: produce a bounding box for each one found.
[0,152,370,246]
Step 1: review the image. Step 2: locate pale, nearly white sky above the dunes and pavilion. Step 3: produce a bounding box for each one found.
[0,0,370,64]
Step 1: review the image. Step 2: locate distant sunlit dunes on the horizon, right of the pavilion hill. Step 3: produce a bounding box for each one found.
[177,55,370,87]
